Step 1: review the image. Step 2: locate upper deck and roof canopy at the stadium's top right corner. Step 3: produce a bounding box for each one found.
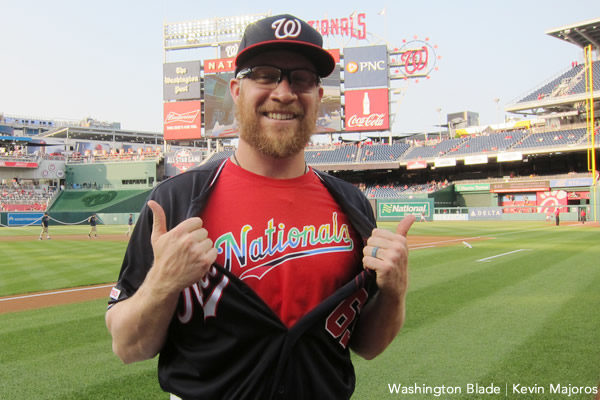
[505,18,600,118]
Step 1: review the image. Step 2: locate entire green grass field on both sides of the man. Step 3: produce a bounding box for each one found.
[0,222,600,400]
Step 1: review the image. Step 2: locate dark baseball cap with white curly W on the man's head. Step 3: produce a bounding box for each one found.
[235,14,335,77]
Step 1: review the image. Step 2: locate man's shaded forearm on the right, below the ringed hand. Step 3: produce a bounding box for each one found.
[350,292,406,360]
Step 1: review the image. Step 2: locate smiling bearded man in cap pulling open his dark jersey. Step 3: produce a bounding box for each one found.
[106,15,414,399]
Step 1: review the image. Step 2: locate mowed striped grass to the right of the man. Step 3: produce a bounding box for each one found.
[355,222,600,399]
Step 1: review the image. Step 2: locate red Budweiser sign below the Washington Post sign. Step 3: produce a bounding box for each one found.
[163,100,202,140]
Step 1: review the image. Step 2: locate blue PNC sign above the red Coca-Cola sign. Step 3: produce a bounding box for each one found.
[344,45,389,89]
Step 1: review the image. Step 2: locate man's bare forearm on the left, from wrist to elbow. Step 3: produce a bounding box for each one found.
[106,270,179,364]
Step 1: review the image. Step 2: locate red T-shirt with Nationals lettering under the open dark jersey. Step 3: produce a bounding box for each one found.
[200,161,362,327]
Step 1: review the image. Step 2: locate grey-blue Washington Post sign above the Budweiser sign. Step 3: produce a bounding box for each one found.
[163,61,201,100]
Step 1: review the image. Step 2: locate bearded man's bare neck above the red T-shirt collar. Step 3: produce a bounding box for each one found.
[231,140,308,179]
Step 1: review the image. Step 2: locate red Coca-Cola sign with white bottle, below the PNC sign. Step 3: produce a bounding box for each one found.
[345,89,390,131]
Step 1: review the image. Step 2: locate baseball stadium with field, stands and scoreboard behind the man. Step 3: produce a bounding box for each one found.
[0,14,600,400]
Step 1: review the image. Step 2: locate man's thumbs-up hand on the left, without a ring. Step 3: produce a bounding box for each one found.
[148,200,217,293]
